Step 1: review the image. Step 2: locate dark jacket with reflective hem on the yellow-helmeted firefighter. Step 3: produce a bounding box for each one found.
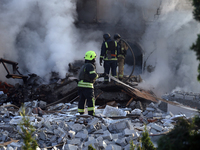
[78,60,98,88]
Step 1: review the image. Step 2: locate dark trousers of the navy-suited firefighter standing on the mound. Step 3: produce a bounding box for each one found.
[104,60,117,82]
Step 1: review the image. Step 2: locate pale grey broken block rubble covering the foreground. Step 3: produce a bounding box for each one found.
[0,101,188,150]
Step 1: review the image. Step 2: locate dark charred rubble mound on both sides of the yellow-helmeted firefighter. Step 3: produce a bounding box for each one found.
[0,73,157,113]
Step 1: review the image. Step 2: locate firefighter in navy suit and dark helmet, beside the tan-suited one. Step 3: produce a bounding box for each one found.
[100,33,118,84]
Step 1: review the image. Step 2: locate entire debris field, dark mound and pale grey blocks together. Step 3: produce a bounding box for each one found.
[0,72,200,150]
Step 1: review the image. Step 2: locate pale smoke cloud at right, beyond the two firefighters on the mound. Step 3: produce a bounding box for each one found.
[138,0,200,95]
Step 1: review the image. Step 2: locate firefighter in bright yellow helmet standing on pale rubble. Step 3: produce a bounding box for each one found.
[78,51,98,115]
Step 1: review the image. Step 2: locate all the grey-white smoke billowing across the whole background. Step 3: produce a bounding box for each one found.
[0,0,200,95]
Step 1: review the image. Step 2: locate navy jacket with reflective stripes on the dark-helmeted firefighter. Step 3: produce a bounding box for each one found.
[100,38,118,61]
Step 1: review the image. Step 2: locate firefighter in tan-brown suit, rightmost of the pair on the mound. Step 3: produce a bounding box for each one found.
[114,33,128,80]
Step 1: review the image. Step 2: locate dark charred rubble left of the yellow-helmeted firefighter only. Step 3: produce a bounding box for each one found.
[0,74,77,106]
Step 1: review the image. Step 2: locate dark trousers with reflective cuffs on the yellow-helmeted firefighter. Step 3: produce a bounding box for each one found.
[78,87,95,116]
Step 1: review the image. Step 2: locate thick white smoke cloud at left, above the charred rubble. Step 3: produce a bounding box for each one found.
[0,0,102,82]
